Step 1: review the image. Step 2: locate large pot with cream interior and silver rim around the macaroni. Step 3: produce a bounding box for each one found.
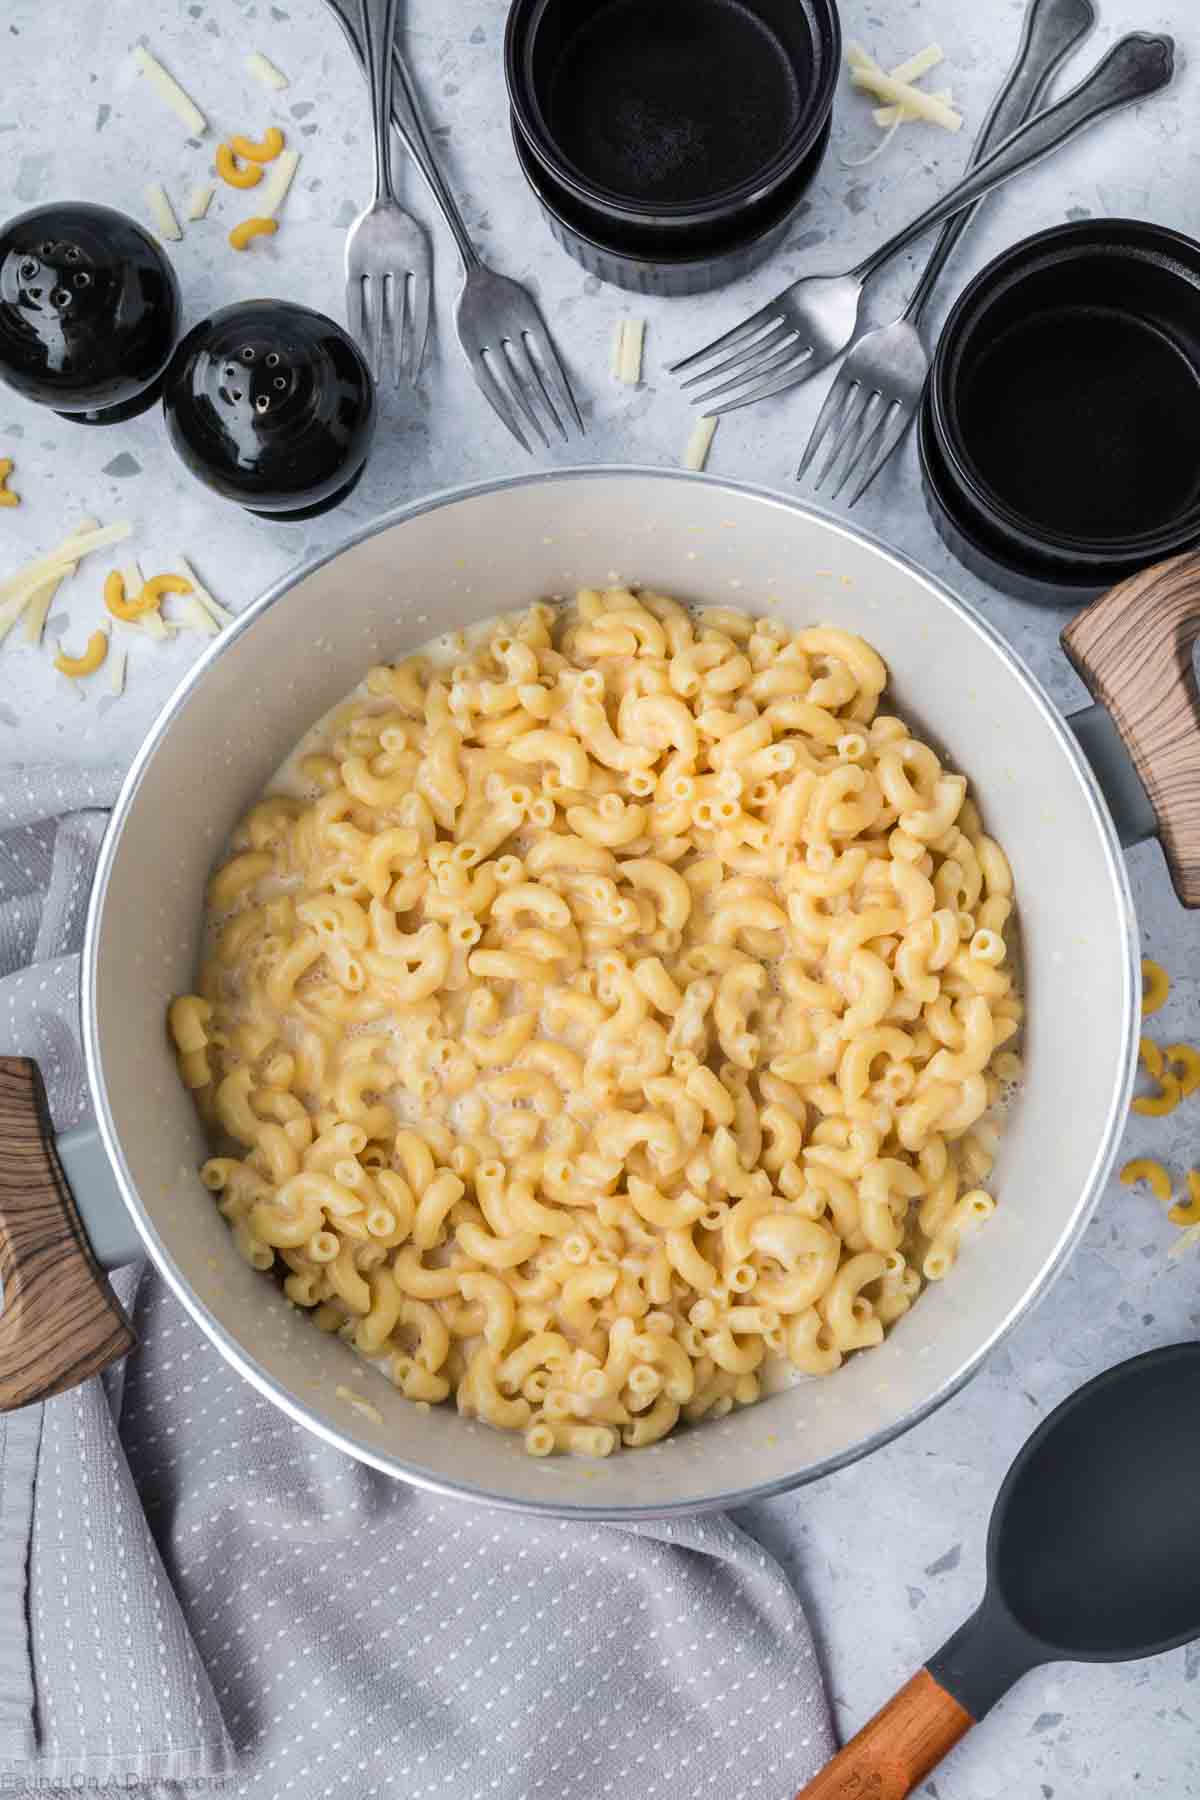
[0,468,1194,1517]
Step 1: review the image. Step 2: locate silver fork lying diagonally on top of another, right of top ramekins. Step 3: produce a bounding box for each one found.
[675,31,1175,414]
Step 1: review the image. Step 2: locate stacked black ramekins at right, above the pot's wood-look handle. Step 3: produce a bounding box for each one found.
[918,220,1200,605]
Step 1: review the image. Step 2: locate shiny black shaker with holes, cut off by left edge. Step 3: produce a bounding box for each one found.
[0,200,180,425]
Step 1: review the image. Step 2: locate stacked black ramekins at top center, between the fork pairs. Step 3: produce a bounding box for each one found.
[506,0,842,293]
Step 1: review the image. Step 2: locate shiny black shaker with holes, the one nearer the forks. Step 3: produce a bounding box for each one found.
[162,301,376,520]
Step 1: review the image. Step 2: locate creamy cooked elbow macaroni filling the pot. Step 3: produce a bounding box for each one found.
[169,589,1022,1456]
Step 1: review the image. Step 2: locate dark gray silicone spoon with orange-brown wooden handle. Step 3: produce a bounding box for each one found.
[797,1343,1200,1800]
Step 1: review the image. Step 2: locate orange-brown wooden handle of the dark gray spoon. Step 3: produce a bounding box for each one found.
[795,1669,975,1800]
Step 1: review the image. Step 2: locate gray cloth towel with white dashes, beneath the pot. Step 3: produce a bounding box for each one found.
[0,769,831,1800]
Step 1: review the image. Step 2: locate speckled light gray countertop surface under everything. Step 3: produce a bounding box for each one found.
[0,0,1200,1800]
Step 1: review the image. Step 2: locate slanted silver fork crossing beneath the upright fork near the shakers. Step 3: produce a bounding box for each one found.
[329,0,585,450]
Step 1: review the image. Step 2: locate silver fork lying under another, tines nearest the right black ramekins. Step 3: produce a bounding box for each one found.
[795,0,1096,506]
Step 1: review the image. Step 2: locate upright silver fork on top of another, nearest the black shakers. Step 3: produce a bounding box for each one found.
[345,0,432,385]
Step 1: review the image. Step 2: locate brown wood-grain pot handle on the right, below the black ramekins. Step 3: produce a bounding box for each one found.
[1061,551,1200,907]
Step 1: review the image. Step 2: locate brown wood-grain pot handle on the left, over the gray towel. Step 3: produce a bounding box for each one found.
[0,1057,135,1413]
